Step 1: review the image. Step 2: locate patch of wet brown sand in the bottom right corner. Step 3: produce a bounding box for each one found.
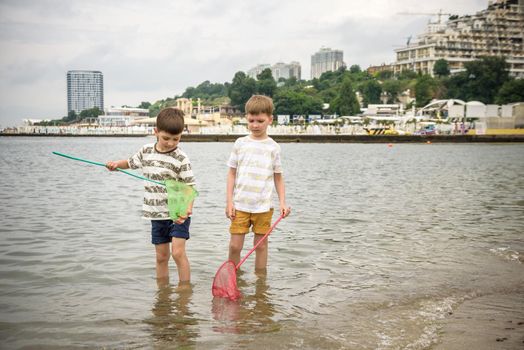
[434,292,524,350]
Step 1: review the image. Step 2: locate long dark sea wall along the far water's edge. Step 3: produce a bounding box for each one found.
[0,133,524,143]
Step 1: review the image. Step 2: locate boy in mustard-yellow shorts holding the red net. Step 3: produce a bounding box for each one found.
[226,95,291,270]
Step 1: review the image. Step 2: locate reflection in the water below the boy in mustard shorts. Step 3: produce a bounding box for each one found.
[211,271,280,334]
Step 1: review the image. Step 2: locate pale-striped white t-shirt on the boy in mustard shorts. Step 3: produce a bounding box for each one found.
[227,135,282,213]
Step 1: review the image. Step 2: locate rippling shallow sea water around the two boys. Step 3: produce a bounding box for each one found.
[0,137,524,349]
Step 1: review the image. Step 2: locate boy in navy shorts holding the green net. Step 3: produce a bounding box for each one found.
[106,108,195,283]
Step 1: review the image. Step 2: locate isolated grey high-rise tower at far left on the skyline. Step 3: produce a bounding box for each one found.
[67,70,104,114]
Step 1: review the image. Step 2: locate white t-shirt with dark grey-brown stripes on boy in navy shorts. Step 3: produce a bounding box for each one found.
[127,143,195,220]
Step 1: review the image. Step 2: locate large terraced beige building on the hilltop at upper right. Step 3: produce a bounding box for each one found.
[394,0,524,78]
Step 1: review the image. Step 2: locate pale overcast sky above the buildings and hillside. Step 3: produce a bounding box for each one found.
[0,0,487,128]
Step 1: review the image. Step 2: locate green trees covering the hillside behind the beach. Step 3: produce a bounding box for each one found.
[34,57,524,125]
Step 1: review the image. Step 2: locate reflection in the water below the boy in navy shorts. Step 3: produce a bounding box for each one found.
[145,281,199,348]
